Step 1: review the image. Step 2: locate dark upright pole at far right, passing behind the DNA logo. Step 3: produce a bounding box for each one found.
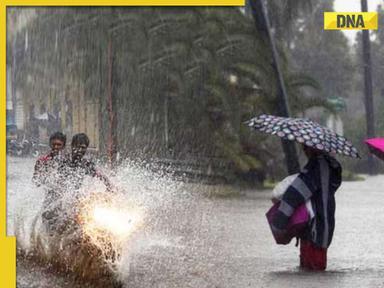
[361,0,377,175]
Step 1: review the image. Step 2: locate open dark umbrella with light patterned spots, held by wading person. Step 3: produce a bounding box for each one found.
[246,114,360,158]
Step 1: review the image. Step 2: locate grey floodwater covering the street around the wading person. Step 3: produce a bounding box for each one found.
[7,158,384,288]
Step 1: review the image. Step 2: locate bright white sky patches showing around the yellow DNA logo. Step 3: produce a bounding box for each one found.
[333,0,384,43]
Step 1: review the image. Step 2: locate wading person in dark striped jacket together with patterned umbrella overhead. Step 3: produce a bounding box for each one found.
[247,115,359,270]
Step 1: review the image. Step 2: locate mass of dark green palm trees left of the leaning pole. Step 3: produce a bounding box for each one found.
[14,7,332,180]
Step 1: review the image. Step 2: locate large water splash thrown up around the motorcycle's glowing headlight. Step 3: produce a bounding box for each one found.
[8,159,210,281]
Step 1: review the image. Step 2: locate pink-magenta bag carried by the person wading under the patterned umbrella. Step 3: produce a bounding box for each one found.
[265,202,310,245]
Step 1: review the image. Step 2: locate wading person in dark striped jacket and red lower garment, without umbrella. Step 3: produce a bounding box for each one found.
[272,146,342,270]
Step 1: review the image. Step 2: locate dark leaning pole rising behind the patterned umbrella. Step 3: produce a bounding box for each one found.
[250,0,300,174]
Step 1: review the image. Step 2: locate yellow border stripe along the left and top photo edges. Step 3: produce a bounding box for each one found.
[0,0,245,288]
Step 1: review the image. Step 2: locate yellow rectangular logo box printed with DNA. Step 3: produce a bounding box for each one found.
[324,12,378,30]
